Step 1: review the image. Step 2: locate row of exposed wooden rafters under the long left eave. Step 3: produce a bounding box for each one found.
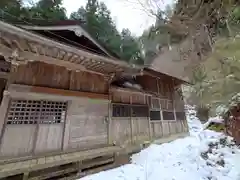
[0,27,140,79]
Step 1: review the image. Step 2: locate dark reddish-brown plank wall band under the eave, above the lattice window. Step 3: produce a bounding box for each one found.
[11,62,108,93]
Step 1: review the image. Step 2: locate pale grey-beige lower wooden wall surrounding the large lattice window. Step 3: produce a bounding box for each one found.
[0,85,109,158]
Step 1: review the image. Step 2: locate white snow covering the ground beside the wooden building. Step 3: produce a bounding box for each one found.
[81,106,240,180]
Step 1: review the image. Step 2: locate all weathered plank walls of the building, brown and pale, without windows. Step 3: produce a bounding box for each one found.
[0,68,188,159]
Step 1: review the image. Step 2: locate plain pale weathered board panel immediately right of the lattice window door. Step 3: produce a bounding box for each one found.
[64,98,109,150]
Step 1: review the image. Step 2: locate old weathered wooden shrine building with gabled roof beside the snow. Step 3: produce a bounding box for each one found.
[0,21,188,179]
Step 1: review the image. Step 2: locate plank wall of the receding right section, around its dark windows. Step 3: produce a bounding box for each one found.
[110,86,188,145]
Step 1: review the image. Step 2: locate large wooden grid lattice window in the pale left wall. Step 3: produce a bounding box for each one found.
[7,100,67,124]
